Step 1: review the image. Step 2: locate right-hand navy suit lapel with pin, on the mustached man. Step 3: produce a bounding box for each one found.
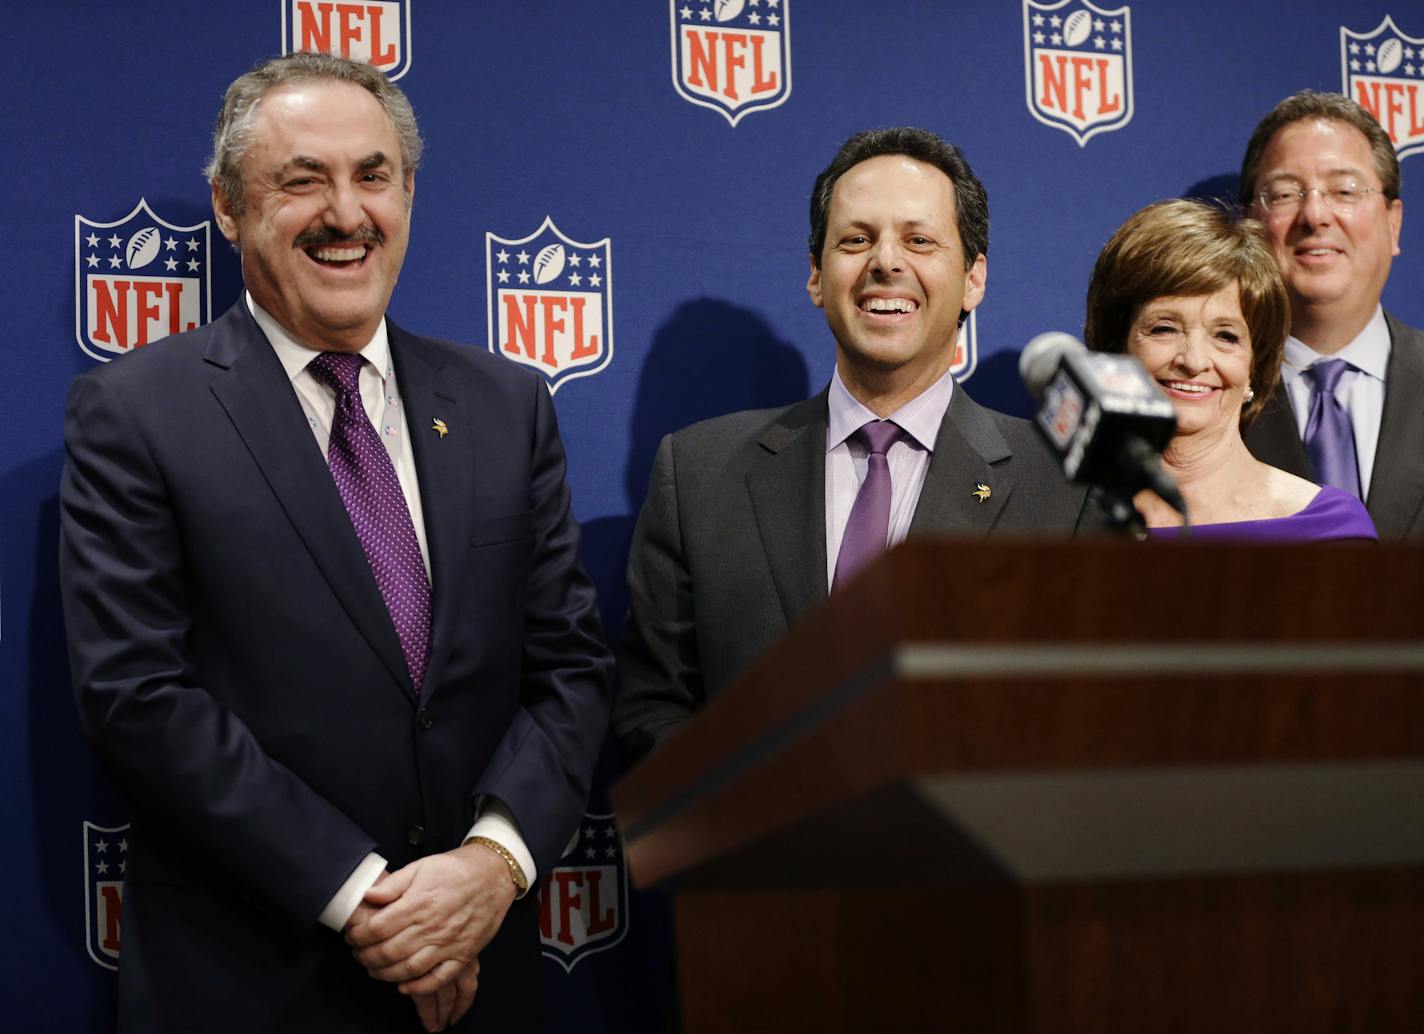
[386,326,472,697]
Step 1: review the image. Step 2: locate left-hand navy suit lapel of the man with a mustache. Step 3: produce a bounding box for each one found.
[204,301,410,692]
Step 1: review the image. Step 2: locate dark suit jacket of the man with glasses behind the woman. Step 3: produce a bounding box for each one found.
[1246,313,1424,540]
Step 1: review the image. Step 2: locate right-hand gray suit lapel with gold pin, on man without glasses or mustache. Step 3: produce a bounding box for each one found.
[910,385,1014,536]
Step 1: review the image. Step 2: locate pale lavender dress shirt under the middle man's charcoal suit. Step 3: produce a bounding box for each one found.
[826,369,954,590]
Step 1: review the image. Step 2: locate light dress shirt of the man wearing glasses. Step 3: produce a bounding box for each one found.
[1280,306,1391,498]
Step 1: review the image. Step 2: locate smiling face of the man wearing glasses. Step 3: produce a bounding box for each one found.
[1250,118,1404,345]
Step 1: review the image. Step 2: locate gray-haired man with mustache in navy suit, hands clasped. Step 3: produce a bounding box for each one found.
[60,54,611,1034]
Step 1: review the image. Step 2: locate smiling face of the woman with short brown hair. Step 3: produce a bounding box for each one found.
[1128,283,1252,436]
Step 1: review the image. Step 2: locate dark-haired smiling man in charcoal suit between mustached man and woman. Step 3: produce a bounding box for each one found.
[614,128,1084,756]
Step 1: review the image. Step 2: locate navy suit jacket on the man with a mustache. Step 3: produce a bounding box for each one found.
[60,302,611,1031]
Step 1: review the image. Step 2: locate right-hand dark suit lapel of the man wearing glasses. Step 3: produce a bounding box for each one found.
[1367,315,1424,538]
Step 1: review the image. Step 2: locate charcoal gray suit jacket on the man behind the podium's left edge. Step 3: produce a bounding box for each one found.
[614,387,1094,756]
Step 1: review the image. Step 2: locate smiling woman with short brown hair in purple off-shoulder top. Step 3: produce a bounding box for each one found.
[1084,201,1377,541]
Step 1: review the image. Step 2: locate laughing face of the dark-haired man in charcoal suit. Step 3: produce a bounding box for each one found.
[806,154,985,397]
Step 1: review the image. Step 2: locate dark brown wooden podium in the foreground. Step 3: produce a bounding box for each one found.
[614,540,1424,1034]
